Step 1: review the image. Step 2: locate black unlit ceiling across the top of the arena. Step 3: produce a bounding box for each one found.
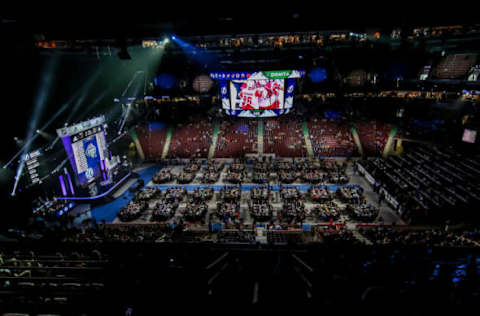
[2,5,478,39]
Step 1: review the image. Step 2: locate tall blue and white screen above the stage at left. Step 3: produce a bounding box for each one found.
[57,116,108,186]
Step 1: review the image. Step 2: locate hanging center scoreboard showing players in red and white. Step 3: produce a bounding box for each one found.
[210,70,305,117]
